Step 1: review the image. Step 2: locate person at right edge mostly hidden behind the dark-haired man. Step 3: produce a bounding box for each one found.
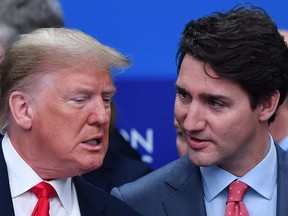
[270,29,288,151]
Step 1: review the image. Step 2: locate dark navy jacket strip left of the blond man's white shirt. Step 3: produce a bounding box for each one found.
[0,139,14,216]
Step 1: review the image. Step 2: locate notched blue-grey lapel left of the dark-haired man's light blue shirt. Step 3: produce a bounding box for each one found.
[162,157,206,216]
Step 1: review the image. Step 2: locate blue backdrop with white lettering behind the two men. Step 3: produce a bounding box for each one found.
[60,0,288,168]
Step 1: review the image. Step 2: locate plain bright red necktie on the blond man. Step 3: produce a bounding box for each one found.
[31,182,57,216]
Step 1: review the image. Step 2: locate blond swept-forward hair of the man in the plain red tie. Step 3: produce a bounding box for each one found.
[0,28,130,134]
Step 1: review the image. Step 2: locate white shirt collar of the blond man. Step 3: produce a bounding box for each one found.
[2,133,74,212]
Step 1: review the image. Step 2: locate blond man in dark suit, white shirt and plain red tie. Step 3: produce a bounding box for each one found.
[0,28,138,216]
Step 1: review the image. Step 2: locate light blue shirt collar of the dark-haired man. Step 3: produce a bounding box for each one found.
[200,136,277,202]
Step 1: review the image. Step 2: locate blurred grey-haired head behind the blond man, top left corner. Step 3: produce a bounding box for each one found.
[0,0,64,55]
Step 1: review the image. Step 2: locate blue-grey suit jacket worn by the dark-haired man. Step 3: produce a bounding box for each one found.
[112,145,288,216]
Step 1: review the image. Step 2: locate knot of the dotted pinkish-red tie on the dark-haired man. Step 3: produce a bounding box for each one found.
[227,181,249,202]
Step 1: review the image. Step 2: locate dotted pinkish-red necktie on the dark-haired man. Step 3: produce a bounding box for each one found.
[225,181,249,216]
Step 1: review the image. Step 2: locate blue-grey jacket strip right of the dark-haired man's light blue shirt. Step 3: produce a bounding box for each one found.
[276,145,288,216]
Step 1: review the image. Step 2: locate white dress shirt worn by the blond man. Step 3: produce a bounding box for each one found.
[2,134,80,216]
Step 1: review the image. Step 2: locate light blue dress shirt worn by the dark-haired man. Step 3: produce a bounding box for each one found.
[200,136,277,216]
